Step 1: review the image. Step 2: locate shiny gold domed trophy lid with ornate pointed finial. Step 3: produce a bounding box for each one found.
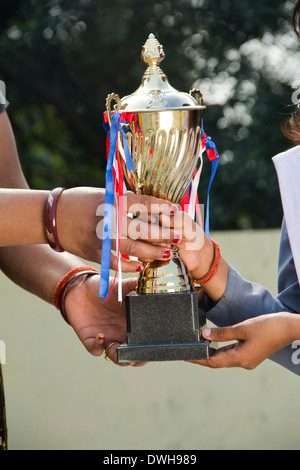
[120,33,205,112]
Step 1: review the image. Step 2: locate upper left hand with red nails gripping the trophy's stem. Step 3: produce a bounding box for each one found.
[57,188,176,272]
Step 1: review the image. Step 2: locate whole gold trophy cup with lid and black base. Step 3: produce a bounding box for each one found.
[106,34,209,363]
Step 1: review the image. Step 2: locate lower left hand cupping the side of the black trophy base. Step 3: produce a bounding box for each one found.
[65,275,141,366]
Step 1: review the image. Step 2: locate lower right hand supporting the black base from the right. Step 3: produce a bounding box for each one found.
[189,312,300,370]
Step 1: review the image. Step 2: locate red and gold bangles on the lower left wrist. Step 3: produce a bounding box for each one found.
[52,266,99,323]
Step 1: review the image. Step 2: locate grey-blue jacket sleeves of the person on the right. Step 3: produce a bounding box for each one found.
[199,221,300,375]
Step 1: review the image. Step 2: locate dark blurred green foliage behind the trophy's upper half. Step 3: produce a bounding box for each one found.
[0,0,300,229]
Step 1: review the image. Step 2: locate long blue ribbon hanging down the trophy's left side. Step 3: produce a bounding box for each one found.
[99,113,134,299]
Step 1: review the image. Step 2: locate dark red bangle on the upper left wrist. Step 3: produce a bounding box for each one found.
[45,188,65,252]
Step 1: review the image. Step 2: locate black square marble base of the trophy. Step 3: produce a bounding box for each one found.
[117,292,209,363]
